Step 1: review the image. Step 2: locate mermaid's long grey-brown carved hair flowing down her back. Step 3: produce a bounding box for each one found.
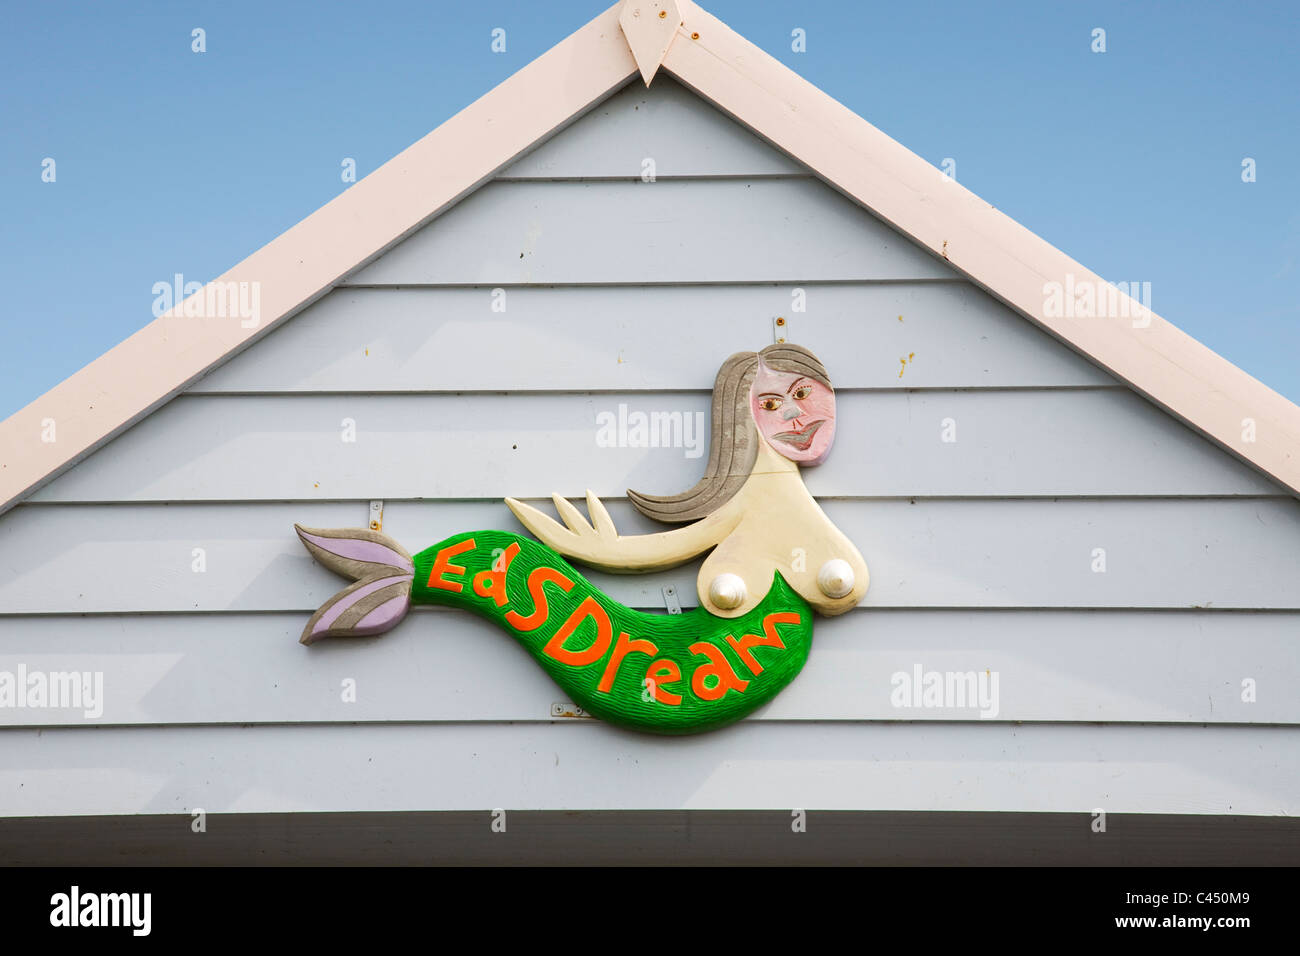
[628,343,831,524]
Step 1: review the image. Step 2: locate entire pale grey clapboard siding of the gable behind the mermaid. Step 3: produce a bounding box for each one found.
[0,63,1300,816]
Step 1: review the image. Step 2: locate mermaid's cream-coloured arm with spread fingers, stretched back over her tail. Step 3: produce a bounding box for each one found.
[506,492,741,571]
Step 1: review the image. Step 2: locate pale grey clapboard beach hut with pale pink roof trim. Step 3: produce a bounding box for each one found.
[0,0,1300,862]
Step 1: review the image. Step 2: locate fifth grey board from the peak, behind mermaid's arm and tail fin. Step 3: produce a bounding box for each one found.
[0,498,1300,613]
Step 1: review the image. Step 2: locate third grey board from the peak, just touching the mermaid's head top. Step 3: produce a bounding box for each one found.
[189,282,1115,394]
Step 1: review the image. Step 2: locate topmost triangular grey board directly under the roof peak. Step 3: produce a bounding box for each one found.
[497,75,807,179]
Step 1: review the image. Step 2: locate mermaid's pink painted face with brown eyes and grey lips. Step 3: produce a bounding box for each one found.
[749,363,835,464]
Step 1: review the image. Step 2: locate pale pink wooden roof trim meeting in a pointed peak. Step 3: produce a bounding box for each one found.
[0,0,1300,512]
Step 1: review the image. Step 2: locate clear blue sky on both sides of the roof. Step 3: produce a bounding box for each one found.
[0,0,1300,418]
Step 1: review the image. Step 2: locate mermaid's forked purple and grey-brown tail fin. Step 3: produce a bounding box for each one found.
[294,524,415,644]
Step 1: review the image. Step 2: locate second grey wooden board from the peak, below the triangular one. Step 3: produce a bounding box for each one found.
[343,178,956,285]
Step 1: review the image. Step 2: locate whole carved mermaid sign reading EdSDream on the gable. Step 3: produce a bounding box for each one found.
[295,345,867,734]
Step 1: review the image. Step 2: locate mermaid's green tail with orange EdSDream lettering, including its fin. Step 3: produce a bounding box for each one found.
[299,528,813,734]
